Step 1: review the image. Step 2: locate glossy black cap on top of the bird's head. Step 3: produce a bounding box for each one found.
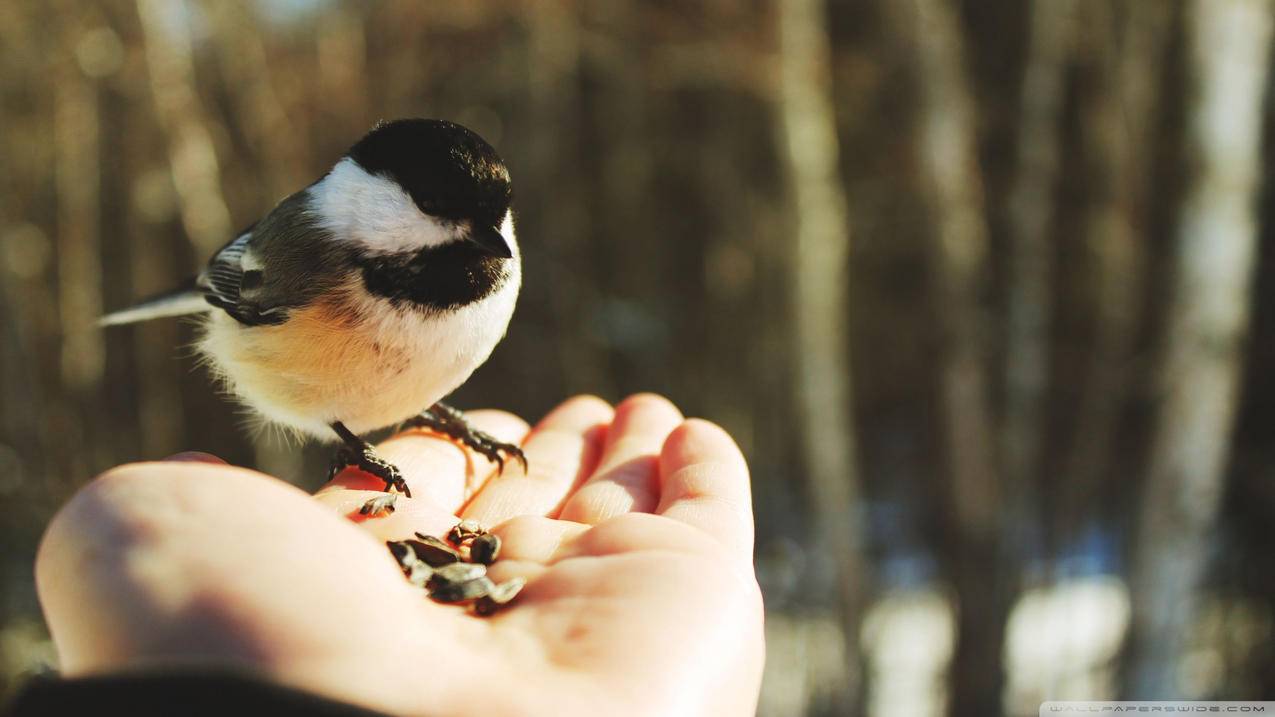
[349,119,513,227]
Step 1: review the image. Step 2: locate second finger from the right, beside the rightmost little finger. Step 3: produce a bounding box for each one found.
[558,393,682,524]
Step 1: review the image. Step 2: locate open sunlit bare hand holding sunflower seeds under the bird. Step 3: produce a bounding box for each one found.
[36,394,764,717]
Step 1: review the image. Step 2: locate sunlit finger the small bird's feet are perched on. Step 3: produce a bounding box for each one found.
[315,410,528,514]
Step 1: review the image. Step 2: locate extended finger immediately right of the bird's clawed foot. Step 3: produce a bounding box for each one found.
[464,395,615,526]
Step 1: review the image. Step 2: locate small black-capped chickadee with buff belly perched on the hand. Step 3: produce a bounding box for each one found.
[99,119,527,514]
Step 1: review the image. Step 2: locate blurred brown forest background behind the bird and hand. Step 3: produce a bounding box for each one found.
[0,0,1275,717]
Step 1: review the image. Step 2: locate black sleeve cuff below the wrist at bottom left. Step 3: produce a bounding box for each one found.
[3,670,386,717]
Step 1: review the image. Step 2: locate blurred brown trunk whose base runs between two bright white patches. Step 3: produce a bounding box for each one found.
[881,0,1005,716]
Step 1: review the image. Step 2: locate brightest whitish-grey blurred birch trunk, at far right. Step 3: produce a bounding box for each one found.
[1130,0,1272,699]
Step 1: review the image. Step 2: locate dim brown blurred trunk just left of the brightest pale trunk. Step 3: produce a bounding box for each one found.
[1056,0,1173,537]
